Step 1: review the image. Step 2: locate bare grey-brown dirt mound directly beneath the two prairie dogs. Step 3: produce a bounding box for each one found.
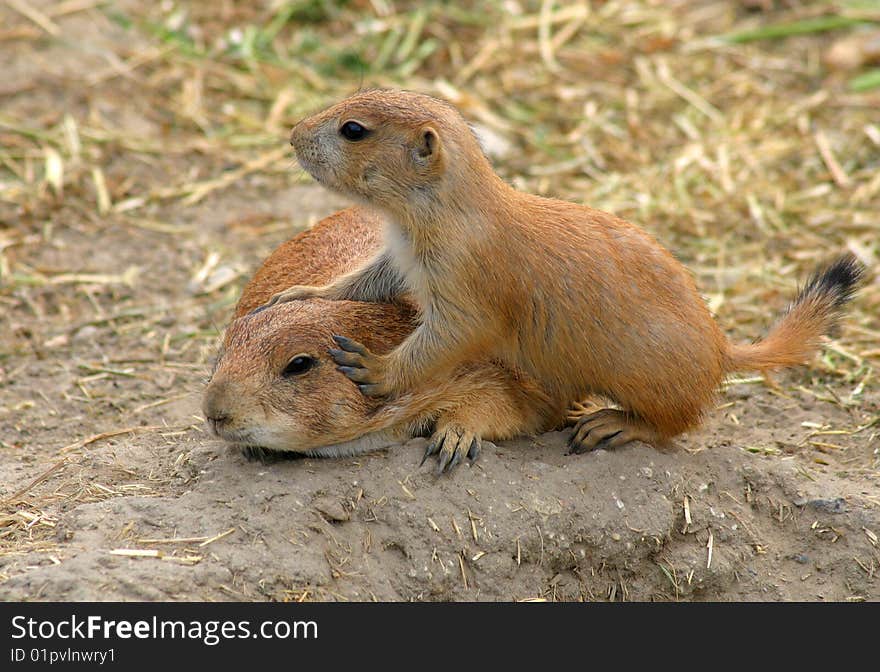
[0,412,880,600]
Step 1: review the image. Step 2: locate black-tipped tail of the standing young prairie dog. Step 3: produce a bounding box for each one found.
[727,254,865,372]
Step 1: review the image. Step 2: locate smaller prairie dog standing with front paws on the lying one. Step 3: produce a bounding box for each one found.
[273,90,863,452]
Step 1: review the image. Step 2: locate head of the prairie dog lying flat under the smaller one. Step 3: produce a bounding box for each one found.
[202,300,413,453]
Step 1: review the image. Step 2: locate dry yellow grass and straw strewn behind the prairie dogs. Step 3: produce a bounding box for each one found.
[0,0,880,572]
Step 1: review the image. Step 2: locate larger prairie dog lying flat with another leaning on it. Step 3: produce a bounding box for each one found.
[202,208,564,471]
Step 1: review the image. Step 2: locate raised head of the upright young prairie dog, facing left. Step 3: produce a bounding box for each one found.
[290,90,491,211]
